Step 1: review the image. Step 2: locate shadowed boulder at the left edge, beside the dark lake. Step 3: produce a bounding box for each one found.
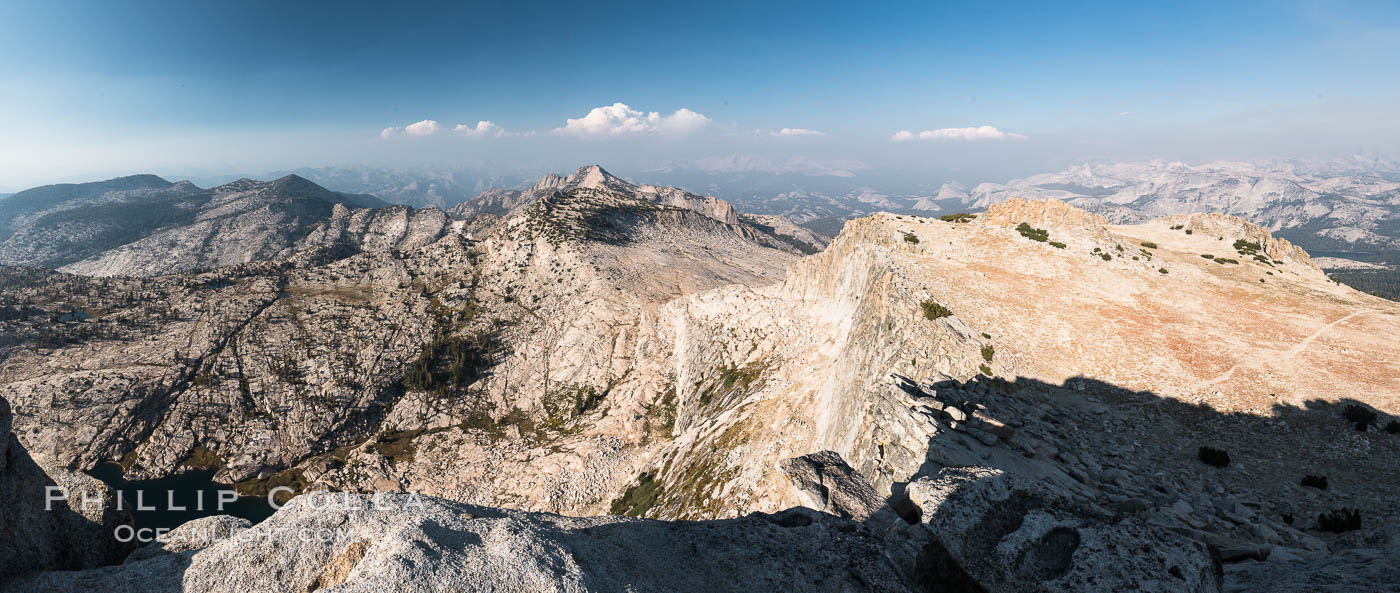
[0,399,134,585]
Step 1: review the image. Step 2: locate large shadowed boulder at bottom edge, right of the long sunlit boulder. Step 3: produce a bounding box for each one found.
[906,467,1221,593]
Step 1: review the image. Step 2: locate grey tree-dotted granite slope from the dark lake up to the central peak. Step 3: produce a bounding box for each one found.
[0,166,797,508]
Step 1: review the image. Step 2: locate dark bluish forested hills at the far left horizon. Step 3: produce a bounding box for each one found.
[0,175,408,276]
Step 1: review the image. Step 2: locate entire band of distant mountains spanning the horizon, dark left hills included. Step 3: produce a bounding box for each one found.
[0,158,1400,276]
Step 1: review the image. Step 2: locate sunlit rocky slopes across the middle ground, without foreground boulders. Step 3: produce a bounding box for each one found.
[0,184,1400,587]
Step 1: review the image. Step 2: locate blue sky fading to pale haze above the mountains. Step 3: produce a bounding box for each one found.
[0,0,1400,189]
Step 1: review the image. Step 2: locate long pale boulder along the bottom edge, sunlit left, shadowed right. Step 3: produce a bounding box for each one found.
[11,494,911,593]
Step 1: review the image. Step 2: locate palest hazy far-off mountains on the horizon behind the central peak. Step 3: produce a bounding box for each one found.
[254,155,1400,262]
